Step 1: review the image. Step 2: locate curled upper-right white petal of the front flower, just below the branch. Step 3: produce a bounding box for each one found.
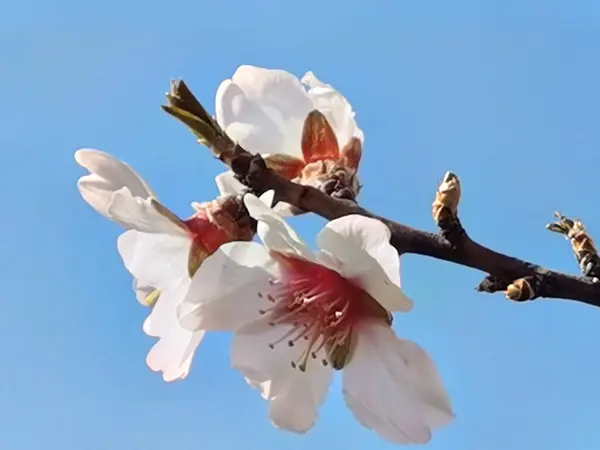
[317,215,413,312]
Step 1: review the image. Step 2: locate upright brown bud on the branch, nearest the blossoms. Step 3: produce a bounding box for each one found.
[432,172,467,247]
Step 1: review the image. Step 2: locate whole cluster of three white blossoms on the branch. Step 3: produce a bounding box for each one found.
[75,66,454,444]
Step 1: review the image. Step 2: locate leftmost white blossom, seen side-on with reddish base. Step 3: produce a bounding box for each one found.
[75,149,254,381]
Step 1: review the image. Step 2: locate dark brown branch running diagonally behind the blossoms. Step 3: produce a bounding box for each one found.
[163,81,600,306]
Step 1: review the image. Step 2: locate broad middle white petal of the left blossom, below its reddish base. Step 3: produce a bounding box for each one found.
[117,230,191,290]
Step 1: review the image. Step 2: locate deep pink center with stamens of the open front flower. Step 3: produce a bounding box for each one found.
[258,252,391,371]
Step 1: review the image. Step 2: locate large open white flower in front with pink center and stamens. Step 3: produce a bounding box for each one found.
[180,191,453,444]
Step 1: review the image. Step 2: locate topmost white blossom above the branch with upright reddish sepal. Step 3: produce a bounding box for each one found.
[216,65,364,213]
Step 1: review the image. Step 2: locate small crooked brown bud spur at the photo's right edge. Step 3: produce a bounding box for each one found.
[546,212,600,277]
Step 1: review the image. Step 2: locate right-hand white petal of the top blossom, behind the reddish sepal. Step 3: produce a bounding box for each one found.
[302,72,364,147]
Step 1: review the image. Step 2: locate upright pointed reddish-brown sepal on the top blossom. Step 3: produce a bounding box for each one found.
[302,110,340,164]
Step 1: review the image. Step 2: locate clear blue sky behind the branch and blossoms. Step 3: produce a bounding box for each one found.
[0,0,600,450]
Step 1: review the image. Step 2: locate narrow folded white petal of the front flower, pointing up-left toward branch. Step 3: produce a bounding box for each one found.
[244,194,315,261]
